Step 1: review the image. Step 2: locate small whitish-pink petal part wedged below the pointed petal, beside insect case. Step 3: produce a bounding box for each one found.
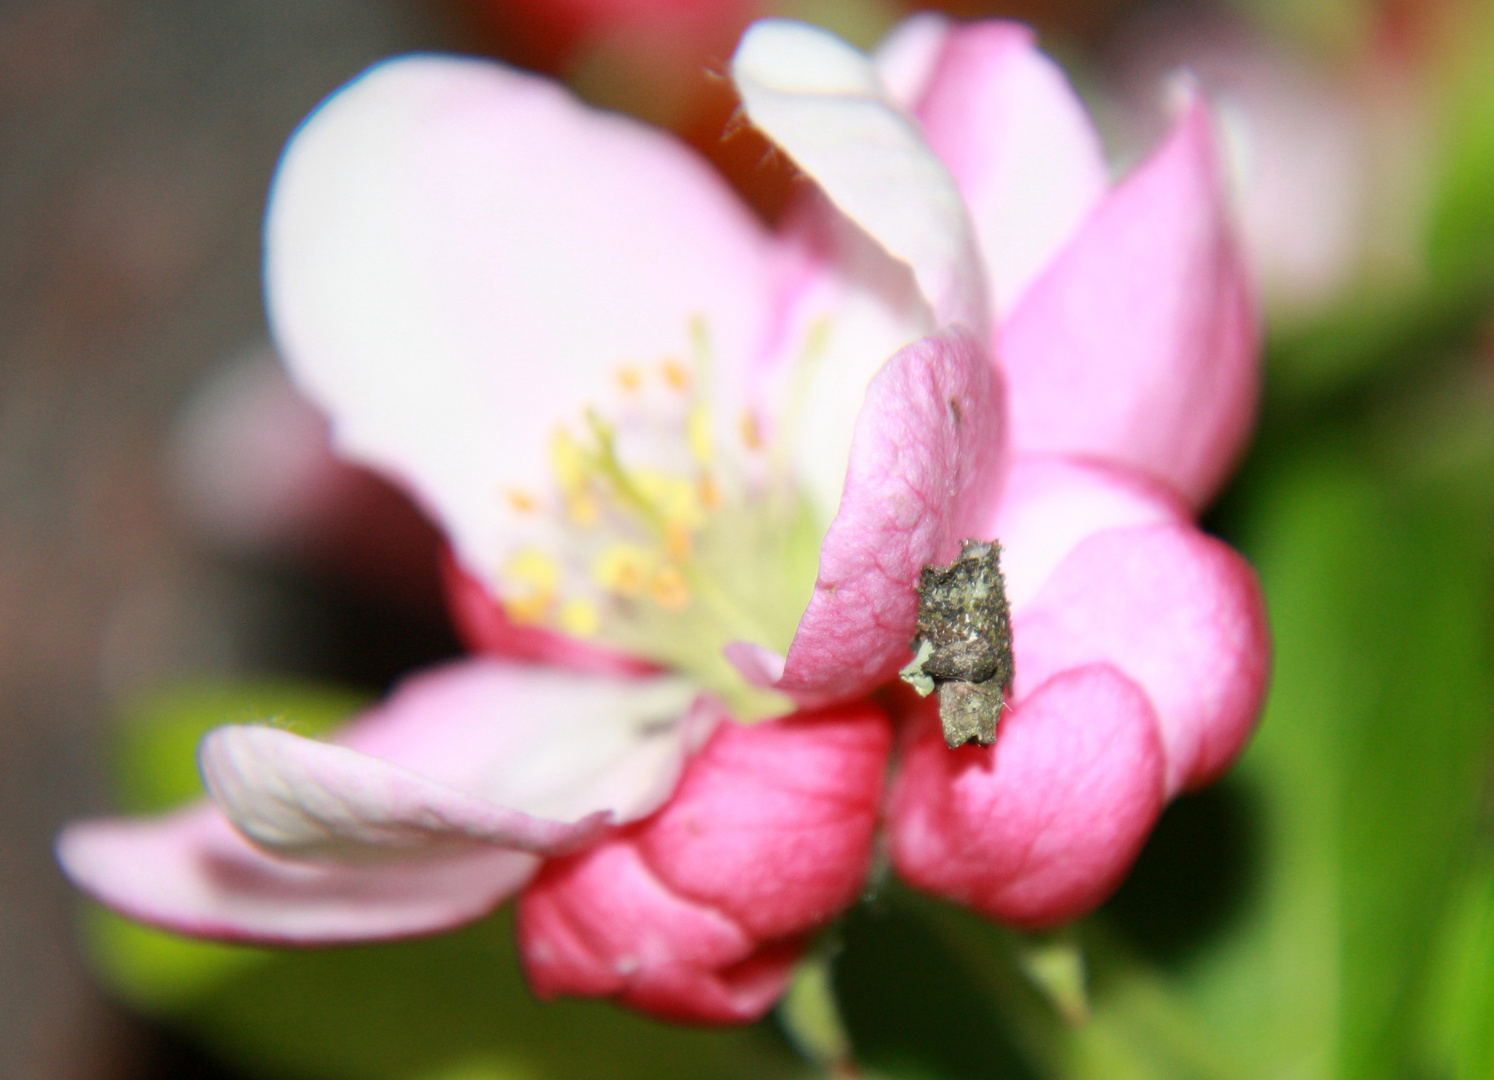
[976,456,1189,612]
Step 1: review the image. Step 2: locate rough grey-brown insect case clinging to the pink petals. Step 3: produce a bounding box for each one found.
[899,539,1013,750]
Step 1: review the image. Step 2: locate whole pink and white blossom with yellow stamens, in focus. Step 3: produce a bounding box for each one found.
[60,16,1265,1022]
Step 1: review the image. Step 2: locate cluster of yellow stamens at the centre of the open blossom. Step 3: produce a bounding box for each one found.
[499,330,825,720]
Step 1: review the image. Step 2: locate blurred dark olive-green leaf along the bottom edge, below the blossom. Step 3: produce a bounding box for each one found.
[166,913,804,1080]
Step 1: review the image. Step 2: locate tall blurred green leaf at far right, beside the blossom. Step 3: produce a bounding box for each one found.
[1189,441,1494,1080]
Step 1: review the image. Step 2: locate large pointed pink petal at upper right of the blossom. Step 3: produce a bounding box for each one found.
[999,103,1258,506]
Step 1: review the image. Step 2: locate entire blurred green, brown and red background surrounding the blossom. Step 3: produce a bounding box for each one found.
[0,0,1494,1080]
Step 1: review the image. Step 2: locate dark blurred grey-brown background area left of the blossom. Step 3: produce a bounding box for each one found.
[0,0,472,1080]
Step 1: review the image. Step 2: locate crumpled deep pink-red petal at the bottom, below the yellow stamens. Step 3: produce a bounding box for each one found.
[518,704,890,1023]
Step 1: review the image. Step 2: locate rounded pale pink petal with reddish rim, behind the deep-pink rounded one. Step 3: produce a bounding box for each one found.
[1013,523,1270,796]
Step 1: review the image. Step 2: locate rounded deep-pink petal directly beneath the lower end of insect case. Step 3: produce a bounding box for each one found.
[889,665,1165,929]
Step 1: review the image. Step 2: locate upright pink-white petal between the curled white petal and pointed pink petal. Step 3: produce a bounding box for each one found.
[916,19,1109,315]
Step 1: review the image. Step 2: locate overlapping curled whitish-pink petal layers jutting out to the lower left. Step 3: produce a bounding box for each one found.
[58,660,717,944]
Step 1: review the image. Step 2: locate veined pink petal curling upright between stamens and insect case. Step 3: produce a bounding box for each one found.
[729,330,1005,705]
